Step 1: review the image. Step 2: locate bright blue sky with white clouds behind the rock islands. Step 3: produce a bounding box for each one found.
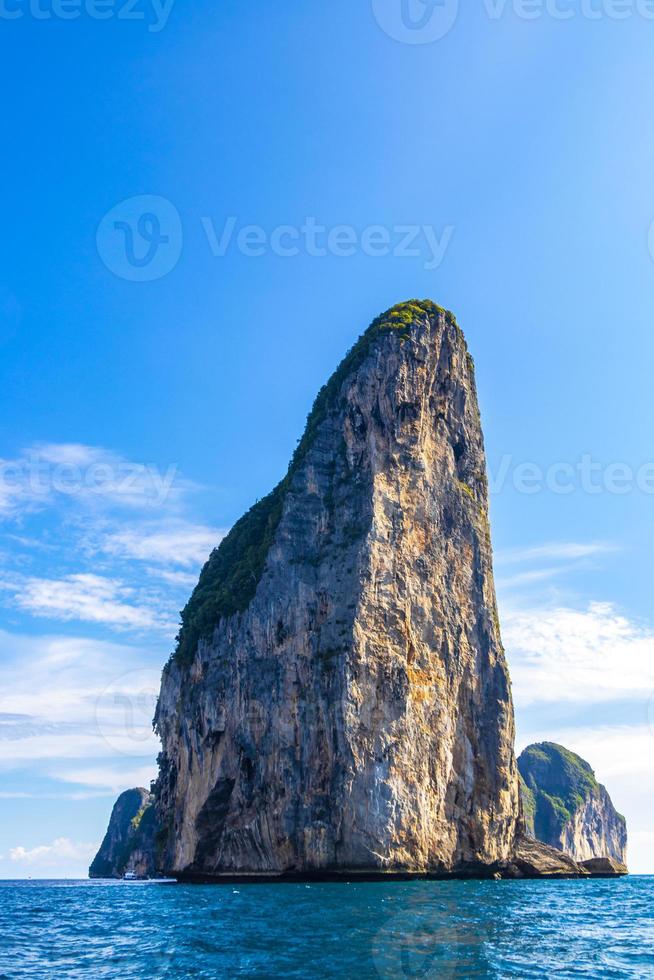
[0,0,654,877]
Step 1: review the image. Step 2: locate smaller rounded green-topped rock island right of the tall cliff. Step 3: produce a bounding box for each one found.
[518,742,627,864]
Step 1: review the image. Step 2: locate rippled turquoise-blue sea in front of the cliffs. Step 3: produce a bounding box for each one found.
[0,877,654,980]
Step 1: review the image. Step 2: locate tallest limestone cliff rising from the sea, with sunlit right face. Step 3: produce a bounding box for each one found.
[155,301,519,877]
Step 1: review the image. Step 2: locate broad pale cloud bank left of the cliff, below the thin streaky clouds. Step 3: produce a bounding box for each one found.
[0,631,165,776]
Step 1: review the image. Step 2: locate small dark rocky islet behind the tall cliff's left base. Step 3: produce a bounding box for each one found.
[89,788,157,878]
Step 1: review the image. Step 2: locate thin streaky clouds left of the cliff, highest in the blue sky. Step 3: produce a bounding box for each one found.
[0,443,213,636]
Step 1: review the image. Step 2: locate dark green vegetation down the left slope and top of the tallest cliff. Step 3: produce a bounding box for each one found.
[173,300,457,665]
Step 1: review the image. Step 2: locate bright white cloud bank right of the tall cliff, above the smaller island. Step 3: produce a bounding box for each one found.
[490,541,654,873]
